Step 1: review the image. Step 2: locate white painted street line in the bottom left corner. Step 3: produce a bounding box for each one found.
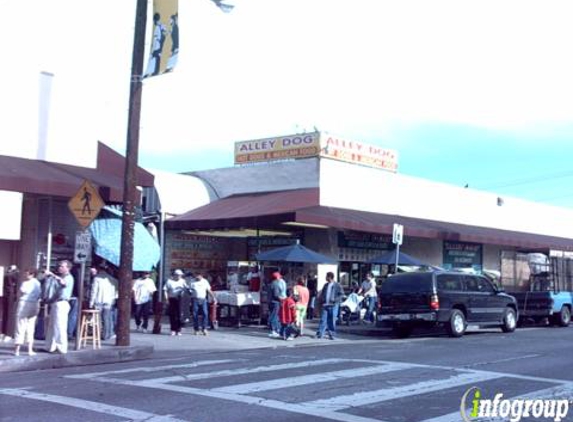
[0,388,184,422]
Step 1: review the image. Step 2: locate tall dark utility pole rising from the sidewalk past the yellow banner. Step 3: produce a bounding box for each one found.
[116,0,147,346]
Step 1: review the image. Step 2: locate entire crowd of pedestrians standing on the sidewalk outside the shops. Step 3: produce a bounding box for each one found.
[4,260,377,356]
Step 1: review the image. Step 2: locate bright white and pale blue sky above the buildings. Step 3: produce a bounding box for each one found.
[0,0,573,207]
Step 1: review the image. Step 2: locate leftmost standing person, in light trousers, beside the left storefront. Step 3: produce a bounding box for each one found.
[14,269,42,356]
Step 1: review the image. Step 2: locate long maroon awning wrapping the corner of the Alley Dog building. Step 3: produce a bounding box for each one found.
[165,188,573,250]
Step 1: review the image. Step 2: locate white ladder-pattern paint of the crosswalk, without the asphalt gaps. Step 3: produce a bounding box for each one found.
[68,358,573,422]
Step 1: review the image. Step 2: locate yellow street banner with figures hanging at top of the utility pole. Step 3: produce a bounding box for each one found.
[143,0,179,78]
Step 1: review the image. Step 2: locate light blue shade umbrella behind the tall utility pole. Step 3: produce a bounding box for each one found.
[90,207,161,271]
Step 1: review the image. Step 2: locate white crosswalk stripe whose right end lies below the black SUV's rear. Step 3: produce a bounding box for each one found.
[211,363,411,394]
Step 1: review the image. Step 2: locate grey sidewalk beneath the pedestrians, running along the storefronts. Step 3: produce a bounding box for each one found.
[0,320,387,372]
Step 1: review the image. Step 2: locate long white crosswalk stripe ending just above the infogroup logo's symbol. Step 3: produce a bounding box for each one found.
[300,371,500,411]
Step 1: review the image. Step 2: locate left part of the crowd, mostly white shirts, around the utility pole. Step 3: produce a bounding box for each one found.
[7,260,220,356]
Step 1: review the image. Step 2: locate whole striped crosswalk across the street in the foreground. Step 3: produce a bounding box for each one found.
[0,356,573,422]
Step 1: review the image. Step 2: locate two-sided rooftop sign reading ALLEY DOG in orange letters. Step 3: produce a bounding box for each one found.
[235,132,398,172]
